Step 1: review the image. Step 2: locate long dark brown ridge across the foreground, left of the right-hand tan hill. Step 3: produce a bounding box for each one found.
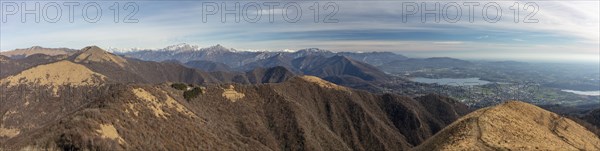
[0,78,468,150]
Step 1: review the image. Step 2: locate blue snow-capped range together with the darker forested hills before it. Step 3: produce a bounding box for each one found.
[113,44,407,85]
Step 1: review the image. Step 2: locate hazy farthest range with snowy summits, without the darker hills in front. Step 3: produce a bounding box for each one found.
[115,44,406,68]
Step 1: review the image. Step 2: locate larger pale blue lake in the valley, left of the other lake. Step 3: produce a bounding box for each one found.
[410,77,491,86]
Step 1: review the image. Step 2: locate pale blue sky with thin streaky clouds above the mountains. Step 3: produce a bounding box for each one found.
[0,0,600,62]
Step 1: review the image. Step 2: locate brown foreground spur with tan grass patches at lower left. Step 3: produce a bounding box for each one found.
[0,85,243,150]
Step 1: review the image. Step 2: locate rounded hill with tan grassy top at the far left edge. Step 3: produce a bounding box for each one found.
[0,59,112,142]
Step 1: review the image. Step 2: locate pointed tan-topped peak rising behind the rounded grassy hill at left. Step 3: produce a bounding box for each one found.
[74,46,127,67]
